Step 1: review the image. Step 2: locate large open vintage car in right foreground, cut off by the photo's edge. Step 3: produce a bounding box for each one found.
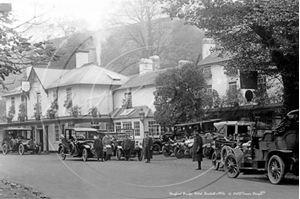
[224,109,299,184]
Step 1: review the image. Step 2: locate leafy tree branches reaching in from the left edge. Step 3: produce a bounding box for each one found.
[0,6,59,82]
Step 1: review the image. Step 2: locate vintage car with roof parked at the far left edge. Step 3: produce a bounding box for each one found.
[2,127,41,155]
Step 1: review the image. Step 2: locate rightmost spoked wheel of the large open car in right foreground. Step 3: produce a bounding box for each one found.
[268,155,285,184]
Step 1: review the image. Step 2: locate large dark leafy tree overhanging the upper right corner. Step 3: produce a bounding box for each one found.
[158,0,299,110]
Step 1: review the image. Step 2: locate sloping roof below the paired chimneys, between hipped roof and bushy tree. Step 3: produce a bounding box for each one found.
[117,69,167,90]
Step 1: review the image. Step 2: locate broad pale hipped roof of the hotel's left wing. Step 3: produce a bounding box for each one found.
[46,63,128,89]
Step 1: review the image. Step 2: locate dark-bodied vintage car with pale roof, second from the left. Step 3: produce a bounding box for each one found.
[58,127,112,161]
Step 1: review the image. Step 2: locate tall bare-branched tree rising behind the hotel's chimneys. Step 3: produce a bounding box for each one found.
[101,0,204,75]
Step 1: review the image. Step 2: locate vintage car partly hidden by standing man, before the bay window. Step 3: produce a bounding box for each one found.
[114,129,144,161]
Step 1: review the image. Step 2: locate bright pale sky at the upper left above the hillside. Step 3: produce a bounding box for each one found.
[0,0,123,30]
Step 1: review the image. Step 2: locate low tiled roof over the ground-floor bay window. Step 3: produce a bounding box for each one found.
[110,106,154,119]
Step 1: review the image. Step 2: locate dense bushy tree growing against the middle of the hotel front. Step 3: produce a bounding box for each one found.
[154,64,207,127]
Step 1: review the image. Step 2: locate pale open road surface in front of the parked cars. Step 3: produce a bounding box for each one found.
[0,153,299,199]
